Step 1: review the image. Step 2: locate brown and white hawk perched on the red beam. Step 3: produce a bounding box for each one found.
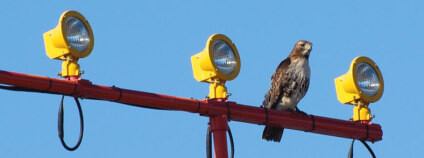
[262,40,312,142]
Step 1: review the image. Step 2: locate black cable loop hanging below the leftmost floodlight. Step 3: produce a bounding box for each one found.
[58,95,84,151]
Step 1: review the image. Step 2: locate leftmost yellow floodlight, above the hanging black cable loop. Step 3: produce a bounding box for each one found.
[43,10,94,77]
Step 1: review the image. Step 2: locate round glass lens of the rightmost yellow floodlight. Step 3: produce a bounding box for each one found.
[356,63,380,96]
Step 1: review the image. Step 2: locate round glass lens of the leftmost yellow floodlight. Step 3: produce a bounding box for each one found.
[65,17,90,51]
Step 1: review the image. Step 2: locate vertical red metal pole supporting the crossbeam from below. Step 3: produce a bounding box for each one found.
[209,115,228,158]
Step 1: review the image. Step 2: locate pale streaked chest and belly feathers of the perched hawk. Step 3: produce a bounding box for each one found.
[277,58,311,110]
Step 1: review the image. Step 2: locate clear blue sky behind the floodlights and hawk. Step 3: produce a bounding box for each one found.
[0,0,424,158]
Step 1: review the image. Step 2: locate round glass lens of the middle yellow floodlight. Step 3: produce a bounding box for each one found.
[212,40,237,74]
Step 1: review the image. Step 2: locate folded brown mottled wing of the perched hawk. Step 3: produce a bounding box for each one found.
[262,58,291,109]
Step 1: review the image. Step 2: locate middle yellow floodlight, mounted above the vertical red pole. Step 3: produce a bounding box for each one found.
[191,34,241,99]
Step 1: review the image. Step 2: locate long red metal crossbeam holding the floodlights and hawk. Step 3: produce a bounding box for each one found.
[0,71,383,142]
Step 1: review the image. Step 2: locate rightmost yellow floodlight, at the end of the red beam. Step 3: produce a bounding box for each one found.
[334,56,384,122]
